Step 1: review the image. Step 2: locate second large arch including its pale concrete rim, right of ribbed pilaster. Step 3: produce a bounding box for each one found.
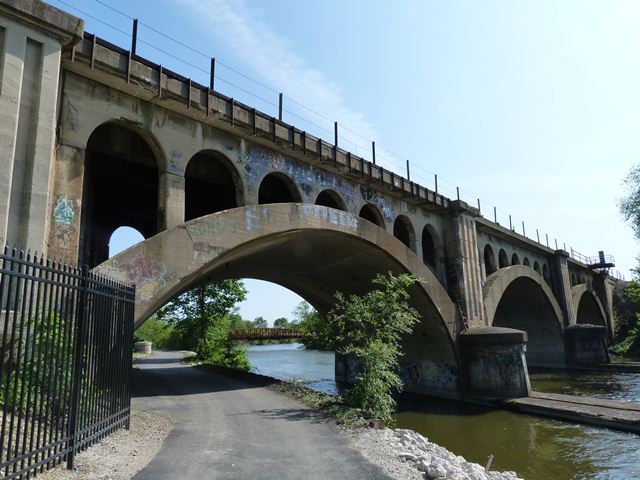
[483,265,565,366]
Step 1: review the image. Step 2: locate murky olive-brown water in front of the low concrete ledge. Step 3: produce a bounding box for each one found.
[396,399,640,480]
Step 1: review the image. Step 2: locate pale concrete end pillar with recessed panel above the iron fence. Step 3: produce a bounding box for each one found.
[0,0,83,251]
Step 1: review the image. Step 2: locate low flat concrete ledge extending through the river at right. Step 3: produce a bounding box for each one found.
[504,392,640,433]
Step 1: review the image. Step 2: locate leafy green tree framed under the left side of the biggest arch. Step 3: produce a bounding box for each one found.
[157,280,247,360]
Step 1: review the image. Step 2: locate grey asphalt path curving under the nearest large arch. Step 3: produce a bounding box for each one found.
[132,352,388,480]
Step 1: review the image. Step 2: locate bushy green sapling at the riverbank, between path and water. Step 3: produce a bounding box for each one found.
[327,272,419,422]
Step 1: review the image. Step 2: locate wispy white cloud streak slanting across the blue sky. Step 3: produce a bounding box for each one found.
[172,0,377,150]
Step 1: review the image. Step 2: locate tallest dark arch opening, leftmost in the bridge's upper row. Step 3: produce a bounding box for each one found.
[79,122,159,267]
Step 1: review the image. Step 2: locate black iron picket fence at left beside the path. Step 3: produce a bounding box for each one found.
[0,247,135,479]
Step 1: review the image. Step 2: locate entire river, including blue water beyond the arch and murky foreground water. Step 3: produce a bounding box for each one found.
[248,343,640,480]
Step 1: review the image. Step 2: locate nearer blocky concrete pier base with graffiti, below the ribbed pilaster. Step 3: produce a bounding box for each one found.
[458,327,531,399]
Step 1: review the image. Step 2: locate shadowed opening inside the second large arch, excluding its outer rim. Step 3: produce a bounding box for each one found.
[493,276,565,367]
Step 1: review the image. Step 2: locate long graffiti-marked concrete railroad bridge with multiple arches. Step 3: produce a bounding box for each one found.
[0,0,615,397]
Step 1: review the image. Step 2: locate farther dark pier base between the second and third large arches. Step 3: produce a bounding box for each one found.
[564,325,609,365]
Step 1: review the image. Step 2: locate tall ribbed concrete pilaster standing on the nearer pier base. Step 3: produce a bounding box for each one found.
[450,200,486,327]
